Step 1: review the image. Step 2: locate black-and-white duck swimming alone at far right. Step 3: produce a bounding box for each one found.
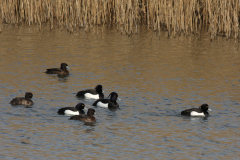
[181,104,211,116]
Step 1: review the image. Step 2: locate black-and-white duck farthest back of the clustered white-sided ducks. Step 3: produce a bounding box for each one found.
[76,85,104,99]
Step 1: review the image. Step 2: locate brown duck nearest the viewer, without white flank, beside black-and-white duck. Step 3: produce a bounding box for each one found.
[69,108,96,122]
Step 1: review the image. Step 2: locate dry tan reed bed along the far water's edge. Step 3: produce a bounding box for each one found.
[0,0,240,38]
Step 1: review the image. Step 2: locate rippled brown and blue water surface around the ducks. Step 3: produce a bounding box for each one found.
[0,26,240,159]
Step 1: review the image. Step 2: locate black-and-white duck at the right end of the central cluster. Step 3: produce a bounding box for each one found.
[93,92,119,109]
